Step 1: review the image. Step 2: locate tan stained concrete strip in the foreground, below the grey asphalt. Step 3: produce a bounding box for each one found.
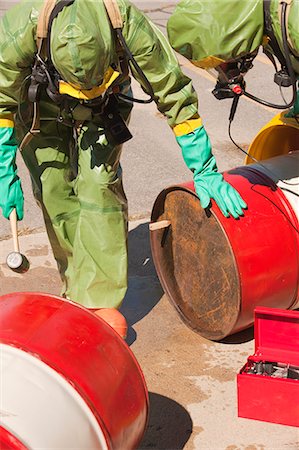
[0,225,299,450]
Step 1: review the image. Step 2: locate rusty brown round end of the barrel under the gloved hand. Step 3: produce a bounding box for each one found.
[150,183,241,340]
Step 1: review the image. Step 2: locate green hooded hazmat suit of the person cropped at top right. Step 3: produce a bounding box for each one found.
[167,0,299,74]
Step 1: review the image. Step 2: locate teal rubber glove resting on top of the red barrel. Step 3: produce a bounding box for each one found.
[176,126,247,219]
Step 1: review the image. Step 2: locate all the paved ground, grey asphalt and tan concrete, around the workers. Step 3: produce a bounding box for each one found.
[0,0,299,450]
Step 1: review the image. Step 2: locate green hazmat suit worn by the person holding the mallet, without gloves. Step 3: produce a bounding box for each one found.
[0,0,247,308]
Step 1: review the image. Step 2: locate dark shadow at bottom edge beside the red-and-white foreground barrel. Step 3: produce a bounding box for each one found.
[138,392,193,450]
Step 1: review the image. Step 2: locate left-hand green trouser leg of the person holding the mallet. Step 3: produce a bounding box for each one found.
[17,114,80,296]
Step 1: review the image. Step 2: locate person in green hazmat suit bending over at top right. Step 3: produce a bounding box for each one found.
[167,0,299,121]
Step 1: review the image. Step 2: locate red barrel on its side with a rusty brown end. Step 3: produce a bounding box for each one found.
[151,152,299,340]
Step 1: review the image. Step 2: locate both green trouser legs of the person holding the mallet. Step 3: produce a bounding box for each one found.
[18,99,129,308]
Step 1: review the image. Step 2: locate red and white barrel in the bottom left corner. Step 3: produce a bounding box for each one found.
[0,292,148,450]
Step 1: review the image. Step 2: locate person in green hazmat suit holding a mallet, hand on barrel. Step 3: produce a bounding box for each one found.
[0,0,246,308]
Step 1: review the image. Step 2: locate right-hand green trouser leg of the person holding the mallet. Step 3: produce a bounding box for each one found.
[69,122,128,308]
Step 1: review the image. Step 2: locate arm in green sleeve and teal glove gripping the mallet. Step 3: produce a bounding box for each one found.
[0,2,37,220]
